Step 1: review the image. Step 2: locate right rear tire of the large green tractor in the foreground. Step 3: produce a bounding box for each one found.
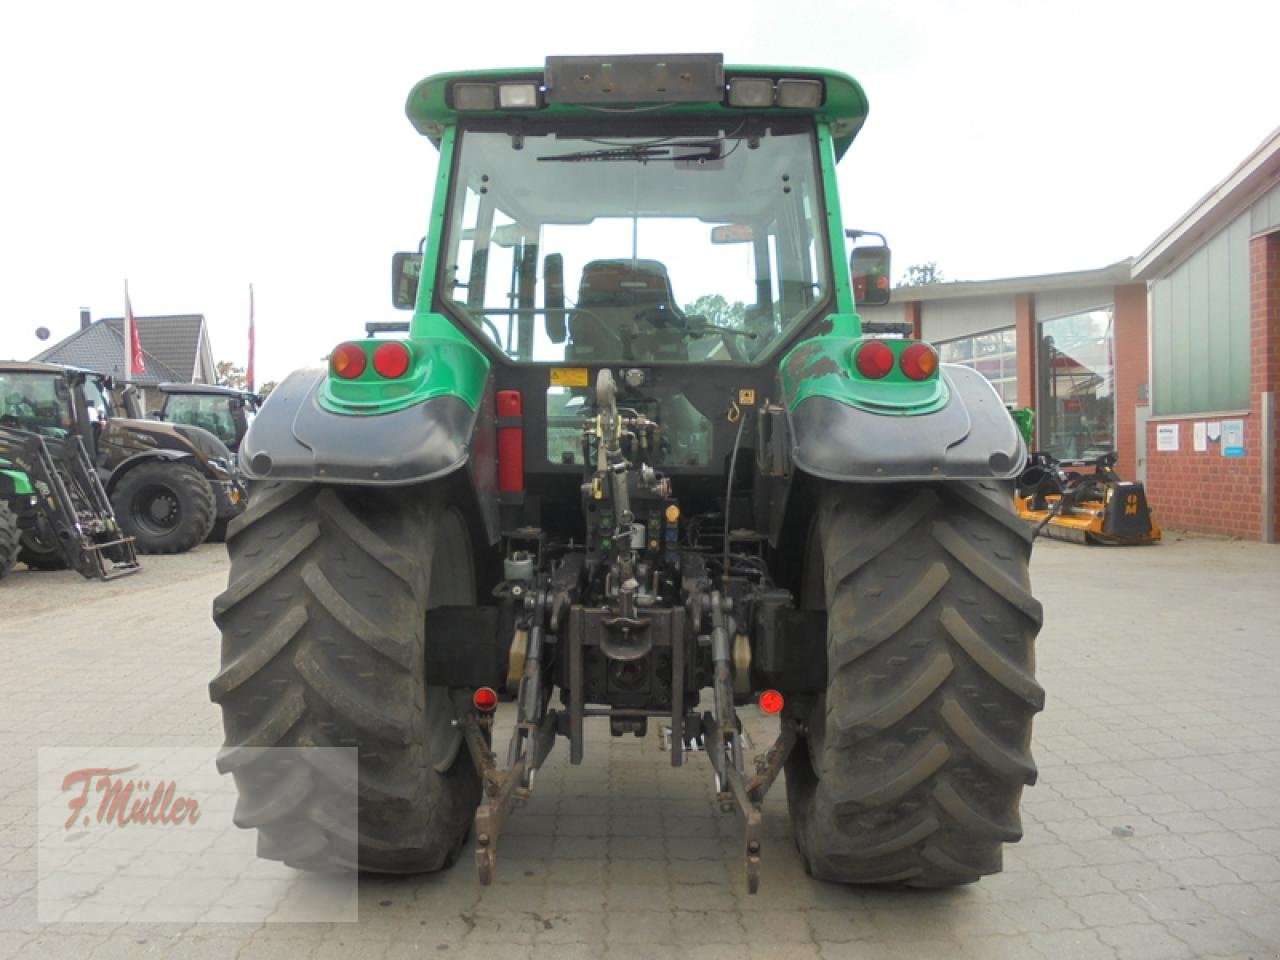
[787,481,1044,887]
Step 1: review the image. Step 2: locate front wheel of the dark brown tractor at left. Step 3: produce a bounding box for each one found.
[111,460,216,553]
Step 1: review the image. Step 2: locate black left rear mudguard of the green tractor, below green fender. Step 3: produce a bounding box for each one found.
[238,369,497,532]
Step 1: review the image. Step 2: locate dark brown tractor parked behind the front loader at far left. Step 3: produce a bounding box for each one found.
[0,362,244,568]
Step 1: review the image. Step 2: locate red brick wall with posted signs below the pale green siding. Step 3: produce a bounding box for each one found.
[1147,233,1280,540]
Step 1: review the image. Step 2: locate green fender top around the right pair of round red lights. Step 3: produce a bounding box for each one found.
[781,335,948,416]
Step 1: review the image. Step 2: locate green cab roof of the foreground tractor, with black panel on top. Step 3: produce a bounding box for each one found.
[404,54,867,159]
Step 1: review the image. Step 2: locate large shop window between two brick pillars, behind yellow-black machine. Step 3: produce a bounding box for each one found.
[1036,306,1116,460]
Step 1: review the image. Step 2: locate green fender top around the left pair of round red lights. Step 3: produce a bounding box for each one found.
[319,332,489,415]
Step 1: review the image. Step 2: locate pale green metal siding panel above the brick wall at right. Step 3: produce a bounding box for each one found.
[1151,212,1251,416]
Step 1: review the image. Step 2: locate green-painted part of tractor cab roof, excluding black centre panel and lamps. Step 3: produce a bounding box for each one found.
[404,65,867,157]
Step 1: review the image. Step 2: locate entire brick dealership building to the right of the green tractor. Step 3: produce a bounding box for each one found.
[864,129,1280,543]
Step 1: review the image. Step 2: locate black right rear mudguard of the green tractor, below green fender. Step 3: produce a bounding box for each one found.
[788,364,1027,483]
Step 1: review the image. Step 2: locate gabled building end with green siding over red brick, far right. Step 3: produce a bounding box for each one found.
[1134,131,1280,543]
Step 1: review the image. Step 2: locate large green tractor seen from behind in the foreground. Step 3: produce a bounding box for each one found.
[210,55,1044,892]
